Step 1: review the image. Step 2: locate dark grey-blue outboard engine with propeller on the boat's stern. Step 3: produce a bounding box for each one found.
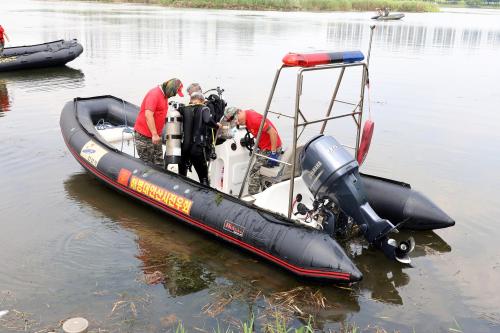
[301,135,414,263]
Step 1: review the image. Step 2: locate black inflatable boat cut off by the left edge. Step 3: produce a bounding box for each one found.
[0,39,83,72]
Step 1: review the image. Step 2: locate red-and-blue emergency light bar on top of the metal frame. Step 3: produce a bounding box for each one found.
[283,51,365,67]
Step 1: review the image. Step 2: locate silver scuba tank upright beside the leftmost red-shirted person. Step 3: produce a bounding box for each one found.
[164,103,182,166]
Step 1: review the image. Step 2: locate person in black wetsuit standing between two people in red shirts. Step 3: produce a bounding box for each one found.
[179,91,221,186]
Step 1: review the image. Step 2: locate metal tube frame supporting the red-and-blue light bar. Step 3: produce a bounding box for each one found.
[238,26,375,218]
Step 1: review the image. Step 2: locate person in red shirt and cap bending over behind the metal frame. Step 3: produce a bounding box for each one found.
[225,107,281,194]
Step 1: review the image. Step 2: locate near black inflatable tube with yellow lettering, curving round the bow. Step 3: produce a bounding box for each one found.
[60,96,362,283]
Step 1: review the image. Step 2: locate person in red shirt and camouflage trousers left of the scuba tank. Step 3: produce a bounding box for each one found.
[134,78,184,167]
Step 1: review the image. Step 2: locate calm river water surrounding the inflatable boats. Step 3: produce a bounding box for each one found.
[0,0,500,332]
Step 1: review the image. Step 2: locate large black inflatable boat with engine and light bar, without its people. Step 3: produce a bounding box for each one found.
[60,31,455,283]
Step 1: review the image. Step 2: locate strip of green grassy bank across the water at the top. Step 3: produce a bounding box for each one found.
[72,0,440,13]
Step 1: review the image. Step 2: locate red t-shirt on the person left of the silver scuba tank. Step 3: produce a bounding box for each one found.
[134,87,168,138]
